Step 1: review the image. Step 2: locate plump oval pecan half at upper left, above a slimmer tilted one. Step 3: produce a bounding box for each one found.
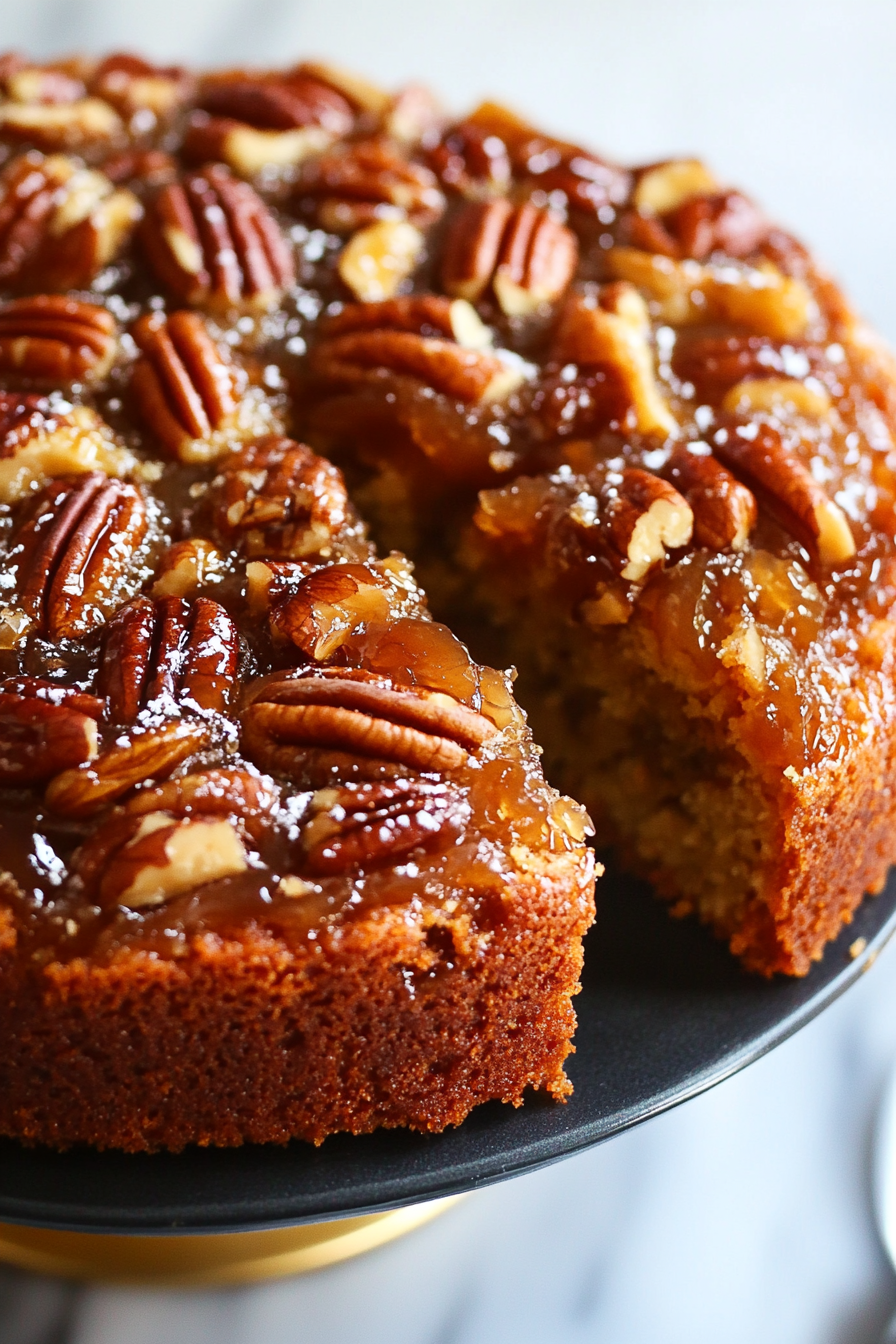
[141,164,296,310]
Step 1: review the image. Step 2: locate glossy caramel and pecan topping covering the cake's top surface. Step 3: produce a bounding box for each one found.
[0,58,896,958]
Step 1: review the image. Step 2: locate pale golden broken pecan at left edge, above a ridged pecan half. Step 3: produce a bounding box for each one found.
[0,392,136,504]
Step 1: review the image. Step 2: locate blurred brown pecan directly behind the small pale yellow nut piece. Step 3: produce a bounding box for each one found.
[297,137,445,234]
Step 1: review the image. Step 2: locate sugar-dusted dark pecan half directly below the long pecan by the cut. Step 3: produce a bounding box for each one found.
[301,780,470,876]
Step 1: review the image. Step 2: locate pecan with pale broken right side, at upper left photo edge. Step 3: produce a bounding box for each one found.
[0,153,141,289]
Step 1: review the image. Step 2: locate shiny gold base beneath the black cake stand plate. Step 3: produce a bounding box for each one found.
[0,1195,462,1288]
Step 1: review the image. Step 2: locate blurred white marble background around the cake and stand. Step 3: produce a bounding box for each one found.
[0,0,896,1344]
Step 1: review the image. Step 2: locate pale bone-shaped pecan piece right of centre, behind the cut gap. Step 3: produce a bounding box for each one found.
[551,284,677,437]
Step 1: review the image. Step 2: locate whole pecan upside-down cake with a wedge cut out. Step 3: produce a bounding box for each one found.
[0,55,896,1150]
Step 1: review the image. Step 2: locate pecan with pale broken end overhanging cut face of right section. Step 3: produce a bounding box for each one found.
[568,466,693,583]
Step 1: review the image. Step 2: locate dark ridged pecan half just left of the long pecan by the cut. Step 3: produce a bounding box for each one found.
[98,597,239,723]
